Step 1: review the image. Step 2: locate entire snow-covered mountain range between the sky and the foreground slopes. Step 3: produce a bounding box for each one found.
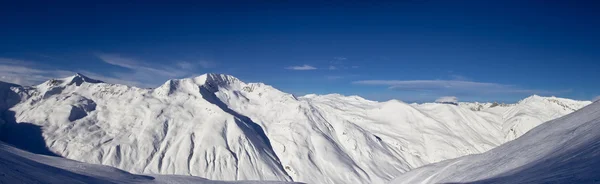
[0,74,590,183]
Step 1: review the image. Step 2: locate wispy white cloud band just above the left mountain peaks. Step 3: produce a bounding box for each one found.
[0,53,216,87]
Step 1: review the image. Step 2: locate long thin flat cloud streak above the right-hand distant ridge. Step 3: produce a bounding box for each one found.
[353,80,564,94]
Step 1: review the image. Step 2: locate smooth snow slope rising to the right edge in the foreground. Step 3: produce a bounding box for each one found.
[392,102,600,183]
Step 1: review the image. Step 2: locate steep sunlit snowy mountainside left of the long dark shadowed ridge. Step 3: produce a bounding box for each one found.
[3,75,291,181]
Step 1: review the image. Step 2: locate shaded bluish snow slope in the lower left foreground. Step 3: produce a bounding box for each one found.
[0,141,298,184]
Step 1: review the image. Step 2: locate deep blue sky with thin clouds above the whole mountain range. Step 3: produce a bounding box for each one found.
[0,0,600,102]
